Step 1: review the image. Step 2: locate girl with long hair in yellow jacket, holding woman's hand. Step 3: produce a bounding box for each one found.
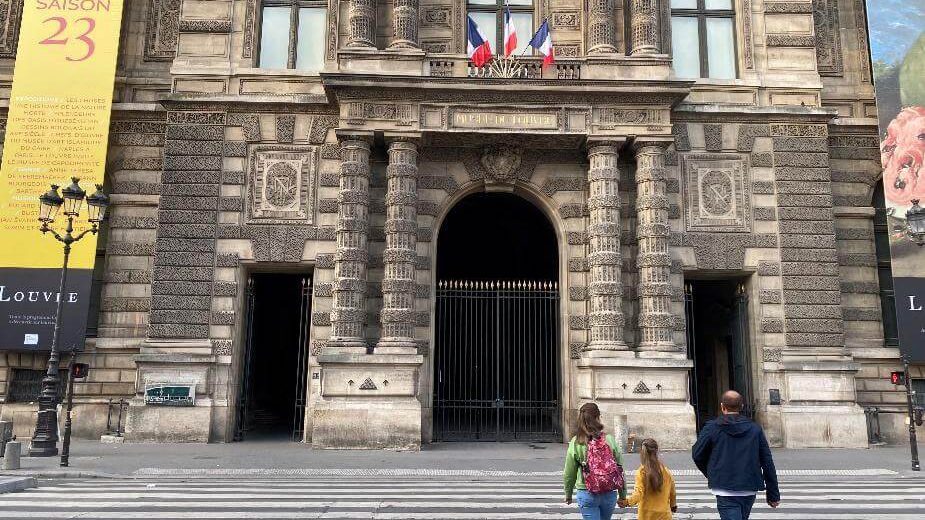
[620,439,678,520]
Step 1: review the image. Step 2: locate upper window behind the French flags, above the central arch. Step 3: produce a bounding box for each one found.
[468,0,533,56]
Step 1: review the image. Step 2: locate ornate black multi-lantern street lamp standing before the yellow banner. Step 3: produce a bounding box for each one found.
[29,177,109,457]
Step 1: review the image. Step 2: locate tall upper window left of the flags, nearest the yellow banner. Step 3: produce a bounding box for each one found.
[259,0,328,72]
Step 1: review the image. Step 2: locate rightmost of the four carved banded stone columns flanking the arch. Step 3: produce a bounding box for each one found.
[636,141,676,351]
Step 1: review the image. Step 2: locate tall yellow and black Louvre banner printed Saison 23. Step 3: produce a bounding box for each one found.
[0,0,123,351]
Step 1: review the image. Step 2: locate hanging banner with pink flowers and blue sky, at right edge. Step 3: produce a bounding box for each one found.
[867,0,925,362]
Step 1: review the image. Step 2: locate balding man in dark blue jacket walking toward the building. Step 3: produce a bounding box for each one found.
[693,390,780,520]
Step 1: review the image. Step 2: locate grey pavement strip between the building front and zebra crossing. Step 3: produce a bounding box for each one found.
[4,440,925,478]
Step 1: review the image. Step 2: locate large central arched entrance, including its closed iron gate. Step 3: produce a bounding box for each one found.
[433,193,561,442]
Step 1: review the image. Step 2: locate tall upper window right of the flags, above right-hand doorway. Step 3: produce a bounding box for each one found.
[671,0,736,79]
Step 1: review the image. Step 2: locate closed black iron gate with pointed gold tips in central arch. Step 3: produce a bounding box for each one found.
[434,280,561,442]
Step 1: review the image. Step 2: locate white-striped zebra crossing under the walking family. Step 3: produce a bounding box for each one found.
[0,476,925,520]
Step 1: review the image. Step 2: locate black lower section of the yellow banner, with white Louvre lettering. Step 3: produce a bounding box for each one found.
[0,267,93,351]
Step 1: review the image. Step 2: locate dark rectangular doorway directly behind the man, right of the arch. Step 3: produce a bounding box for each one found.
[685,278,754,429]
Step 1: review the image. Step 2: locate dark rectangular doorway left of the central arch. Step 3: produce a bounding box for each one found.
[235,273,311,441]
